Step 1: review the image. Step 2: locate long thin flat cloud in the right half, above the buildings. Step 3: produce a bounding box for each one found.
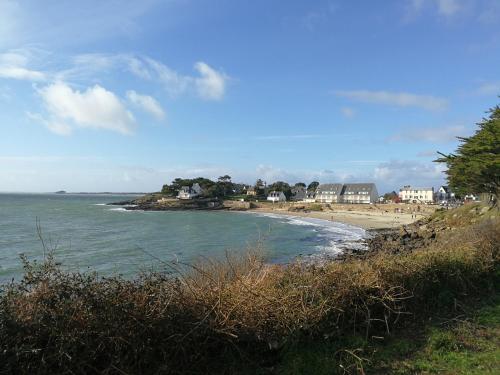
[335,90,448,111]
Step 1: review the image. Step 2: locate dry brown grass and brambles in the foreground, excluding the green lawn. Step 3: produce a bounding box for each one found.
[0,214,500,373]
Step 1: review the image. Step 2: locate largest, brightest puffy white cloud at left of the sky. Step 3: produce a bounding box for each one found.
[39,82,136,134]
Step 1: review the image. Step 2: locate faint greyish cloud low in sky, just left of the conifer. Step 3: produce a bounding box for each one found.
[388,125,469,143]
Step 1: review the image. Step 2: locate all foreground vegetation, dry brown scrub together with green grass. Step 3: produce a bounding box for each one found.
[0,206,500,374]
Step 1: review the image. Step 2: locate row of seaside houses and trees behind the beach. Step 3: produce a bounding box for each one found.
[176,180,472,206]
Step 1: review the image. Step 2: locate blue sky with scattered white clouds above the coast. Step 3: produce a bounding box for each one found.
[0,0,500,193]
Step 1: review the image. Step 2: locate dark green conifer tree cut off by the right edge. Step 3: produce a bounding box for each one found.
[435,105,500,205]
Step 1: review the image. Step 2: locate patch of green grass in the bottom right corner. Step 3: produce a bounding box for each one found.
[277,294,500,375]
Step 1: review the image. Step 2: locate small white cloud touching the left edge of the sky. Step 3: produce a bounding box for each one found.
[0,50,46,81]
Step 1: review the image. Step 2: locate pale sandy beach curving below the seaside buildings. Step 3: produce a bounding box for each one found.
[244,203,435,229]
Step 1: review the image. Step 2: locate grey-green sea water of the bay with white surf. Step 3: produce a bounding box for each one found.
[0,194,366,282]
